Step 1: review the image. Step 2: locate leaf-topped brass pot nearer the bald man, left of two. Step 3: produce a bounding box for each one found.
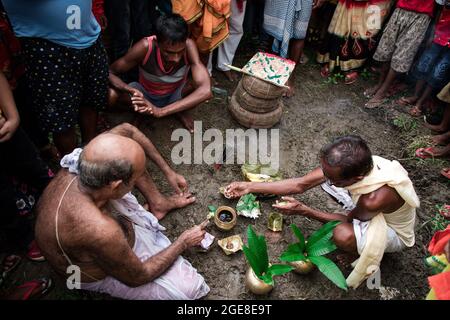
[242,226,294,295]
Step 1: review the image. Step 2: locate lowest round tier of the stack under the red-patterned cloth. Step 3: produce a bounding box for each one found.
[228,95,283,129]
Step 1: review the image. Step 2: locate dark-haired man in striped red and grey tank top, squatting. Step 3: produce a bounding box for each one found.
[109,14,211,132]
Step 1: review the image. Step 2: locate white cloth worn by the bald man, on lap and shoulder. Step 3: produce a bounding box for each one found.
[61,148,210,300]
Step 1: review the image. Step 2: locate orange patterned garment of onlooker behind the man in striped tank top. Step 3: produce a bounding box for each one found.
[172,0,231,53]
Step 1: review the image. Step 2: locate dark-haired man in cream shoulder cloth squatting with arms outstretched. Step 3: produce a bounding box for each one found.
[225,136,419,282]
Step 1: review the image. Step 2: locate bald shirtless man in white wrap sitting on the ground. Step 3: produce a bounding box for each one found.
[36,124,209,299]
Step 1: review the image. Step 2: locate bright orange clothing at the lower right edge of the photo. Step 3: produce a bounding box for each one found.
[428,226,450,300]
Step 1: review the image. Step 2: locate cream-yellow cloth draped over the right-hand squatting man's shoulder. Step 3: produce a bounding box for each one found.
[346,156,420,288]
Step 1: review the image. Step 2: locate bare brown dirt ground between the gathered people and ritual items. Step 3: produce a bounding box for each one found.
[1,38,450,300]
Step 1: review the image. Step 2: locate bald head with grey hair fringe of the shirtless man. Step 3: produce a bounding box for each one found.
[78,133,145,190]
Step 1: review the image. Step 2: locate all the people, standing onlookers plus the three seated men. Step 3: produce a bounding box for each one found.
[0,0,450,299]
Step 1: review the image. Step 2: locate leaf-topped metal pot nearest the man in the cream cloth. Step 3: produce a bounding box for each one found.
[280,221,347,290]
